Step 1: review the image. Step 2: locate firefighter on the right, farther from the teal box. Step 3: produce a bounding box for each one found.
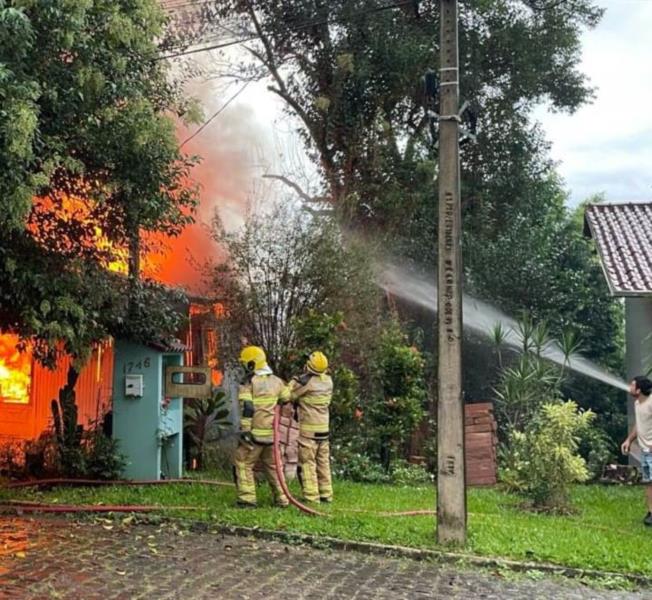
[290,352,333,502]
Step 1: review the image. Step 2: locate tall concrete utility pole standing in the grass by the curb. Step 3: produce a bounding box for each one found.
[437,0,466,544]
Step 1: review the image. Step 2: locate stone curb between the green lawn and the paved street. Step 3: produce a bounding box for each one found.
[205,522,652,588]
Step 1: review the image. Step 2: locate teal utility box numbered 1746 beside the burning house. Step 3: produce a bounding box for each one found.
[113,340,183,480]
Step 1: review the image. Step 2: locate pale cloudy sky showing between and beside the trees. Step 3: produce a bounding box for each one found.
[181,0,652,212]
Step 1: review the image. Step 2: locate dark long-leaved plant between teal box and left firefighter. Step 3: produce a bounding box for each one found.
[183,390,231,469]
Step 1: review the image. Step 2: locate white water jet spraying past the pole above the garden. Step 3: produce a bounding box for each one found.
[379,264,628,391]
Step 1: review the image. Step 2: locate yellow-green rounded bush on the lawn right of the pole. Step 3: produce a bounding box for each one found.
[501,401,594,510]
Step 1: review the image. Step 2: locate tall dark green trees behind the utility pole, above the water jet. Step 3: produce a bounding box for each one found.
[204,0,620,380]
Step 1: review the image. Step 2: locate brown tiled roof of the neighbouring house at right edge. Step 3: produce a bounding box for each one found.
[584,202,652,296]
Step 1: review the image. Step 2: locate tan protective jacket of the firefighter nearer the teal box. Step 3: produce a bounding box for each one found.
[238,367,290,444]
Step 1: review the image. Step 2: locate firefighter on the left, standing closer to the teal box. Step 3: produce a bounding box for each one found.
[234,346,290,507]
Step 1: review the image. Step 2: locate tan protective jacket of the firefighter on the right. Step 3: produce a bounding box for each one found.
[290,373,333,439]
